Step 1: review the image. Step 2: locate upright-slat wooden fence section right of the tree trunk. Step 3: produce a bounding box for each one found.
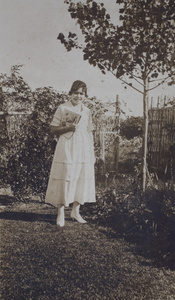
[148,97,175,179]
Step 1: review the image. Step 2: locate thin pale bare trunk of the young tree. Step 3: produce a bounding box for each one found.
[142,78,148,192]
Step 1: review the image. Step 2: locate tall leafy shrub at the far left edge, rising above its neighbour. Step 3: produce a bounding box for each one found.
[0,65,34,191]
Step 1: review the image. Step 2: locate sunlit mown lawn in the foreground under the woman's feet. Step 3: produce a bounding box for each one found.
[0,198,175,300]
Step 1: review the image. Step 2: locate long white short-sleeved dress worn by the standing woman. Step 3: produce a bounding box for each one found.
[45,102,96,207]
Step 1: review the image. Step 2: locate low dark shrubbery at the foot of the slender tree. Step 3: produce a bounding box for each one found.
[84,174,175,269]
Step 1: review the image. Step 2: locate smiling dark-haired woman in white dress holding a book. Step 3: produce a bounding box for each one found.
[46,80,96,227]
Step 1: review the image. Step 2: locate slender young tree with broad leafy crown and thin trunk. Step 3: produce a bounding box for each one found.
[58,0,175,190]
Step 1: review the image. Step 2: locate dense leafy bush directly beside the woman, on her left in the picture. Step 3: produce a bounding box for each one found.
[8,88,64,198]
